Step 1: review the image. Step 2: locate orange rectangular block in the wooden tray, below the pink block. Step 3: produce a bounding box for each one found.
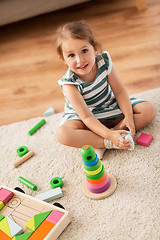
[28,220,55,240]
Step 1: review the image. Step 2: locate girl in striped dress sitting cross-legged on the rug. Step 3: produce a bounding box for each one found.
[56,21,155,158]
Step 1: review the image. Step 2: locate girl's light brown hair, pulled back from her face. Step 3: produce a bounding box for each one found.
[56,21,102,56]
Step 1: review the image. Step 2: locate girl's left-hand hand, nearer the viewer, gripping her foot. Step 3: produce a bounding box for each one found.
[109,130,131,149]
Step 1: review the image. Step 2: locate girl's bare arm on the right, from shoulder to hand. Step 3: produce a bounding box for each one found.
[108,65,135,137]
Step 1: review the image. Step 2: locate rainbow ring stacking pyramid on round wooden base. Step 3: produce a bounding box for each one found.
[81,145,117,200]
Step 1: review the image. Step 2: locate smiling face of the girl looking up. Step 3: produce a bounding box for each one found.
[60,38,97,82]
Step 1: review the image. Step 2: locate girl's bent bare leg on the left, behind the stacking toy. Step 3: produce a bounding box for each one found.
[56,120,105,148]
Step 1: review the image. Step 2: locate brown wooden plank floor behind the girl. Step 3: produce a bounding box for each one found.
[0,0,160,125]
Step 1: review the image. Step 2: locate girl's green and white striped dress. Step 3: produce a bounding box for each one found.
[58,51,143,125]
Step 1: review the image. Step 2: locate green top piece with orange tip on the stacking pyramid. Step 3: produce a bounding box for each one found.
[80,145,96,162]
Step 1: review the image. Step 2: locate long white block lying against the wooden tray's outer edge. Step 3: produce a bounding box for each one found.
[35,187,63,202]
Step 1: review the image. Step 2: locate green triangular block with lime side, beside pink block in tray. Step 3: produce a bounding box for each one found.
[26,210,52,231]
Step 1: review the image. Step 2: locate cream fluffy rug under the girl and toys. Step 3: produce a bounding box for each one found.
[0,88,160,240]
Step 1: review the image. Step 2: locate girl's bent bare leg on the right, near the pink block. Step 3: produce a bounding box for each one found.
[114,102,156,130]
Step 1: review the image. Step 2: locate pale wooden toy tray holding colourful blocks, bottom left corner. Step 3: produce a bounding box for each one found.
[0,186,71,240]
